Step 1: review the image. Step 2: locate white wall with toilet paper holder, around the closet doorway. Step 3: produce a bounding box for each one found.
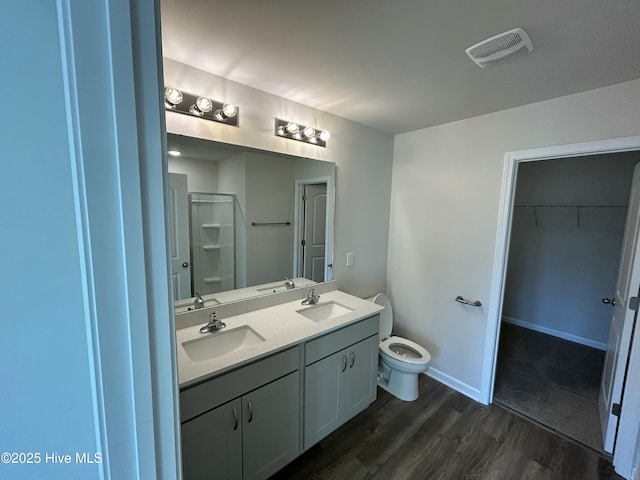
[388,80,640,398]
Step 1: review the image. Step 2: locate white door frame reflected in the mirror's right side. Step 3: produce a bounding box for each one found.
[291,176,336,282]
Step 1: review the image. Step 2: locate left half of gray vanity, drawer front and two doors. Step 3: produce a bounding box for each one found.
[180,347,300,480]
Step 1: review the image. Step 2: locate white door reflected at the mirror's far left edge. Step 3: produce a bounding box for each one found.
[169,173,191,300]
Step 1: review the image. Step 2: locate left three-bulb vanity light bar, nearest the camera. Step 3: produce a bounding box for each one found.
[164,87,239,127]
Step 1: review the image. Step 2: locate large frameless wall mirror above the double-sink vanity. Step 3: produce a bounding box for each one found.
[167,134,336,312]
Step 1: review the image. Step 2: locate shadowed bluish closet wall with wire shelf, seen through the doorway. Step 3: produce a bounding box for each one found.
[503,152,640,349]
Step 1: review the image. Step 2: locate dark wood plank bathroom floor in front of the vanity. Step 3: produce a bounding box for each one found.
[272,375,622,480]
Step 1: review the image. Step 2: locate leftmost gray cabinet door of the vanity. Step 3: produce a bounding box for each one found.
[182,399,242,480]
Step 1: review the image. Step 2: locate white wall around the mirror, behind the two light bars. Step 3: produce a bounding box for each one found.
[164,58,393,296]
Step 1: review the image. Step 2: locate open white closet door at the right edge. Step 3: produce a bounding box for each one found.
[598,164,640,453]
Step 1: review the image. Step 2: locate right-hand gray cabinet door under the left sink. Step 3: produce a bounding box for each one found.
[242,371,300,480]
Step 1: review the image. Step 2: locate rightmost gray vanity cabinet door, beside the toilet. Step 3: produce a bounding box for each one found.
[344,335,378,422]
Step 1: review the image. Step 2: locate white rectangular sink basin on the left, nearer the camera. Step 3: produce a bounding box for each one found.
[182,325,264,363]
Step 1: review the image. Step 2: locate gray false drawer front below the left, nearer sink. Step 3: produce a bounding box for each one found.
[180,347,300,422]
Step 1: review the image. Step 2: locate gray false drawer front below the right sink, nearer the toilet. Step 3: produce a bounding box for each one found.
[305,314,380,365]
